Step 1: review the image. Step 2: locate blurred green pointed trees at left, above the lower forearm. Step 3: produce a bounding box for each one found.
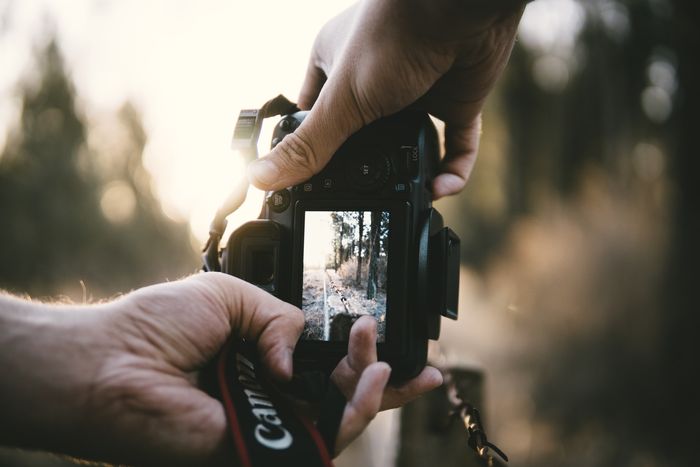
[0,41,197,295]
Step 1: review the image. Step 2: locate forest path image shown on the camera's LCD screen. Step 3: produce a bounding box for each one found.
[301,211,389,342]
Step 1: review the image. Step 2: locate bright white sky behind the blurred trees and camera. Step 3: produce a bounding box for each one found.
[0,0,582,239]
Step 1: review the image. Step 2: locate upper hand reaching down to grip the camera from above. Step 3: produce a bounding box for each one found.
[248,0,524,199]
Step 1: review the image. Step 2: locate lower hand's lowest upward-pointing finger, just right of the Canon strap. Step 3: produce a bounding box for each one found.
[335,362,391,453]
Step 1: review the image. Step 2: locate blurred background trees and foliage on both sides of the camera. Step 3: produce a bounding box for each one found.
[0,0,700,467]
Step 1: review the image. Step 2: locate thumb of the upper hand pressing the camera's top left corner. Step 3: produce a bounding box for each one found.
[248,73,374,191]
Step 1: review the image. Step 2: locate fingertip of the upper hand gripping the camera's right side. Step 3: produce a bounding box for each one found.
[433,115,481,199]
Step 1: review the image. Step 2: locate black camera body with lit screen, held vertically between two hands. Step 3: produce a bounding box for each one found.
[221,110,459,380]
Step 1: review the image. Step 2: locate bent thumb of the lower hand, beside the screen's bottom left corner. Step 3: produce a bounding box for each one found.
[191,272,304,379]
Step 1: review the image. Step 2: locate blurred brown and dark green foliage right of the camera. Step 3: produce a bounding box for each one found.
[439,0,700,467]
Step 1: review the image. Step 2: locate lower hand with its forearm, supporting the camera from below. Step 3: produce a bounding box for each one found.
[0,273,439,465]
